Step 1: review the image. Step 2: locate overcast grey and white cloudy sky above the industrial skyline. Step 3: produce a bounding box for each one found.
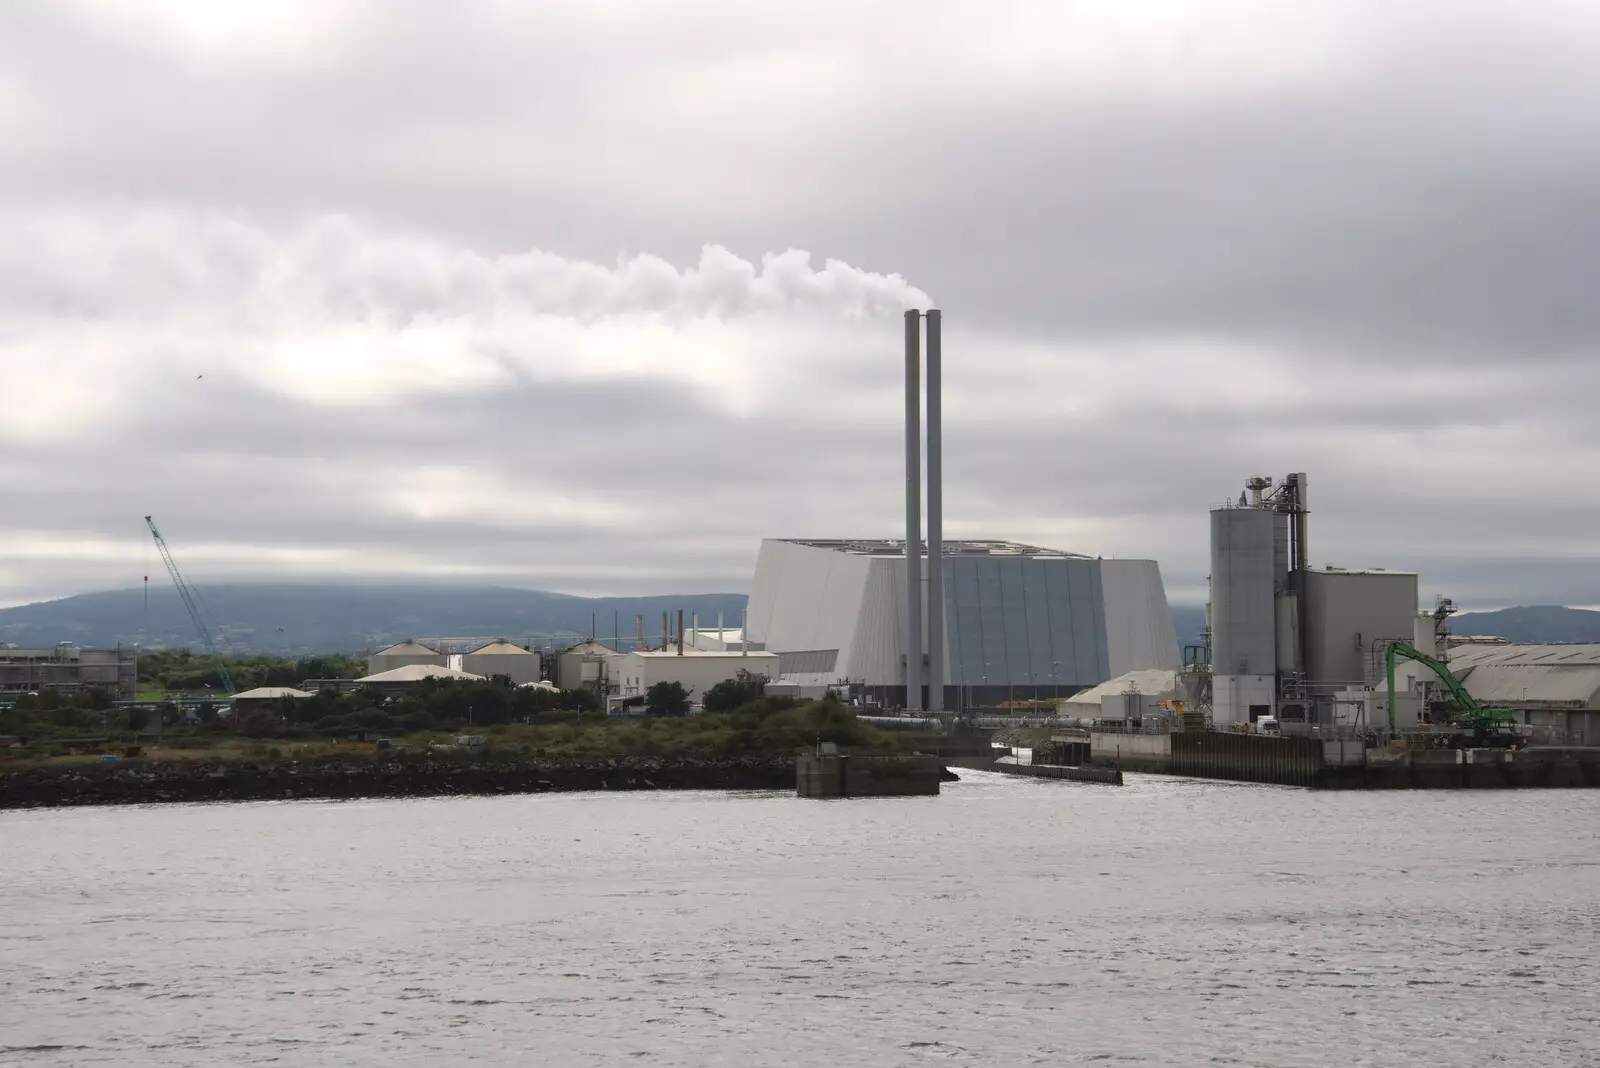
[0,0,1600,606]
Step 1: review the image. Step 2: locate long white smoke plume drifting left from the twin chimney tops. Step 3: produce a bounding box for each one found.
[0,211,928,321]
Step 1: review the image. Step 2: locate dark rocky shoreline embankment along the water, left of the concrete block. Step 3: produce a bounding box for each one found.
[0,756,795,809]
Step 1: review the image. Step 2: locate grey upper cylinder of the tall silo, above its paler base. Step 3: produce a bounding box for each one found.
[1211,508,1278,675]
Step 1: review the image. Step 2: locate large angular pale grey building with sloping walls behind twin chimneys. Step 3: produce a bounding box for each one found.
[747,539,1179,708]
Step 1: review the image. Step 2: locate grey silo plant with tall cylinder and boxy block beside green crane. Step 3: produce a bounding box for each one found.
[1208,473,1418,729]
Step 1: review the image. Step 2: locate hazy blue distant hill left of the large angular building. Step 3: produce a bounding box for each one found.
[0,580,746,656]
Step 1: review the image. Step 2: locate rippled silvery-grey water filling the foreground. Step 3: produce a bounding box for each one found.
[0,772,1600,1068]
